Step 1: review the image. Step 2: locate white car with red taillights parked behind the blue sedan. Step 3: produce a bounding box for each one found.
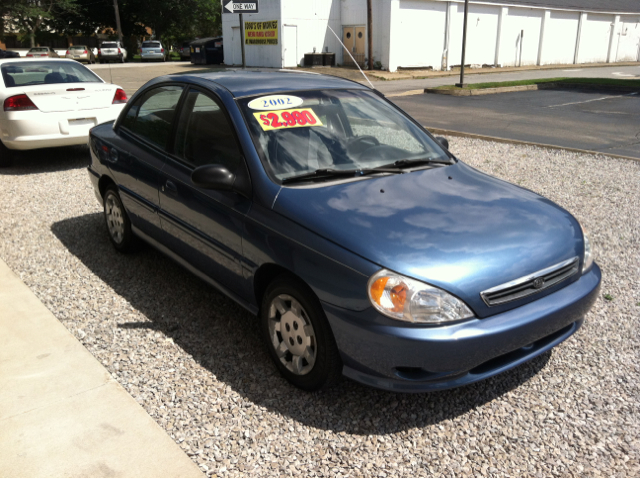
[0,58,127,166]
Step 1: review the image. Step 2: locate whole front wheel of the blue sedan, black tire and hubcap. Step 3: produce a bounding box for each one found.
[260,275,342,391]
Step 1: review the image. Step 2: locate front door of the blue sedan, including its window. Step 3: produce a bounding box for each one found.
[160,88,251,297]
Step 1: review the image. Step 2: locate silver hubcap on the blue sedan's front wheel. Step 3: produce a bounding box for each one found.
[269,294,317,376]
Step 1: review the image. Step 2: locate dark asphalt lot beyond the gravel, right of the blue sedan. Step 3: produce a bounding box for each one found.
[392,89,640,159]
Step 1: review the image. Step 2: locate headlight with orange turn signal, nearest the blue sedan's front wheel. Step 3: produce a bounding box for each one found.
[367,269,473,324]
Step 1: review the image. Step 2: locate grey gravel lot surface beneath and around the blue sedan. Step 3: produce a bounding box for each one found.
[0,138,640,477]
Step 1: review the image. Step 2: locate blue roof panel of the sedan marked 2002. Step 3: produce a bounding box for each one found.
[172,70,369,98]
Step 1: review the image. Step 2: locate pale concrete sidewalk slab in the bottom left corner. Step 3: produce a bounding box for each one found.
[0,259,203,477]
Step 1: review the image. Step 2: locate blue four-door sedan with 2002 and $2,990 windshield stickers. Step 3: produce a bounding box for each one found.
[89,71,601,392]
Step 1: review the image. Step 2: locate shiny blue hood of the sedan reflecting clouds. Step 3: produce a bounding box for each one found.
[274,162,583,317]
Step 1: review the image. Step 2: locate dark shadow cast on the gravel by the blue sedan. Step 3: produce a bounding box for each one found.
[51,213,551,435]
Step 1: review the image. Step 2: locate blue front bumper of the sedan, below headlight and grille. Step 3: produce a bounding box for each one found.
[323,264,601,392]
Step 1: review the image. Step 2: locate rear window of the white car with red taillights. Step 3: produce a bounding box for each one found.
[2,61,102,87]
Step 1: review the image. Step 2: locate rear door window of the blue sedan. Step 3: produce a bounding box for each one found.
[122,85,183,148]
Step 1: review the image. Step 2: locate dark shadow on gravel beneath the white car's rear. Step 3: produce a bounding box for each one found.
[0,145,91,176]
